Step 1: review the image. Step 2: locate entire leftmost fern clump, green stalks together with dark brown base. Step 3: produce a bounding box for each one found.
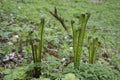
[27,18,45,78]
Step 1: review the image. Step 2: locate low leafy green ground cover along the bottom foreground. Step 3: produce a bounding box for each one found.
[1,56,120,80]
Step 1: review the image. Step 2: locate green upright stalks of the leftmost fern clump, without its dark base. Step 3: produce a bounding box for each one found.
[29,19,45,63]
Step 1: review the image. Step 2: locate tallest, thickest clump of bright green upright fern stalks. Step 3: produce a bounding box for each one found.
[71,13,90,68]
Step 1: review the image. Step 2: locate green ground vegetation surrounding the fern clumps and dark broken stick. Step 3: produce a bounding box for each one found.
[0,0,120,80]
